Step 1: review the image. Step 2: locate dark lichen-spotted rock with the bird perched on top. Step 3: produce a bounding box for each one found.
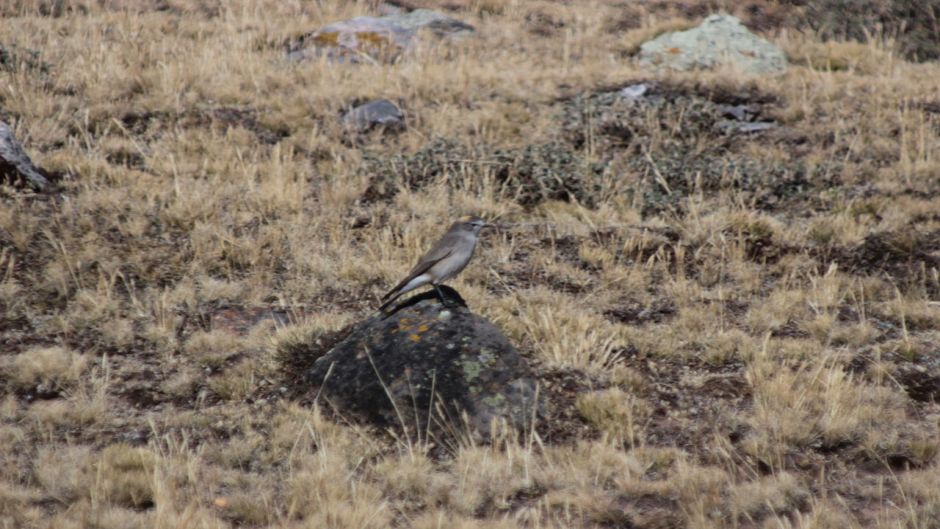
[306,287,536,438]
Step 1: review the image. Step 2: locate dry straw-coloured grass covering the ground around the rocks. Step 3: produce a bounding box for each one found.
[0,0,940,529]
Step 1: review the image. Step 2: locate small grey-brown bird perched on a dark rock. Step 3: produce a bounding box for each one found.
[379,216,495,311]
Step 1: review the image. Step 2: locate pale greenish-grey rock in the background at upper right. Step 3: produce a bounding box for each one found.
[640,15,787,75]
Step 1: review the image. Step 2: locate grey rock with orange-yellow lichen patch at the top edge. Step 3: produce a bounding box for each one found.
[287,9,474,63]
